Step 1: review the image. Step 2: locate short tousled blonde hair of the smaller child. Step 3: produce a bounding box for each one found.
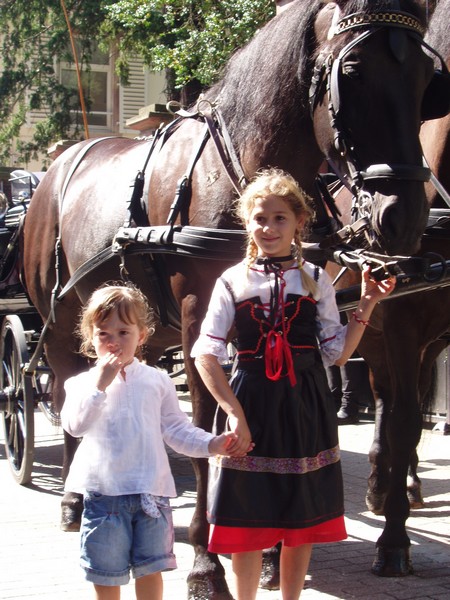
[76,284,155,359]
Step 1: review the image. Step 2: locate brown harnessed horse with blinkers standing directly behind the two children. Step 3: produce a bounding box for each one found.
[24,0,440,599]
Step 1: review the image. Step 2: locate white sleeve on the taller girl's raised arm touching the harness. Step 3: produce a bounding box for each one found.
[317,270,347,367]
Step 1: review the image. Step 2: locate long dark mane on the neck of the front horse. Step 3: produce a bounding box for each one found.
[203,0,425,156]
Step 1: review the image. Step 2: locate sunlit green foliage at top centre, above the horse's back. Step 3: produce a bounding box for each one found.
[102,0,275,88]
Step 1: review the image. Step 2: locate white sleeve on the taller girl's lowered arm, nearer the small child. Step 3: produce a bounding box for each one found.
[191,278,235,363]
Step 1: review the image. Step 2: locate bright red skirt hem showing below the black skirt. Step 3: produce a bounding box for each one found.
[208,516,347,554]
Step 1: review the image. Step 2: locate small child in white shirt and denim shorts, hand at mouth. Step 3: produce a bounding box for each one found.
[61,286,250,600]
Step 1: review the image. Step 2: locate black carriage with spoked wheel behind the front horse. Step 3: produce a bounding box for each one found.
[0,169,59,485]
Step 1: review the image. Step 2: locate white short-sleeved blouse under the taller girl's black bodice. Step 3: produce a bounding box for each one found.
[191,261,347,366]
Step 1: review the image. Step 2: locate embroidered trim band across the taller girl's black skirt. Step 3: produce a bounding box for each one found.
[209,446,341,475]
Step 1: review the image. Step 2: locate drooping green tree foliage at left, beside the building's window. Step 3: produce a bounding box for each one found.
[0,0,110,164]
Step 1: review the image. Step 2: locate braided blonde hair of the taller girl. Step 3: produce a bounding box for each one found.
[235,167,317,295]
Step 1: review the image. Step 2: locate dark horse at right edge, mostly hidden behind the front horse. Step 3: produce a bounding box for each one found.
[327,0,450,577]
